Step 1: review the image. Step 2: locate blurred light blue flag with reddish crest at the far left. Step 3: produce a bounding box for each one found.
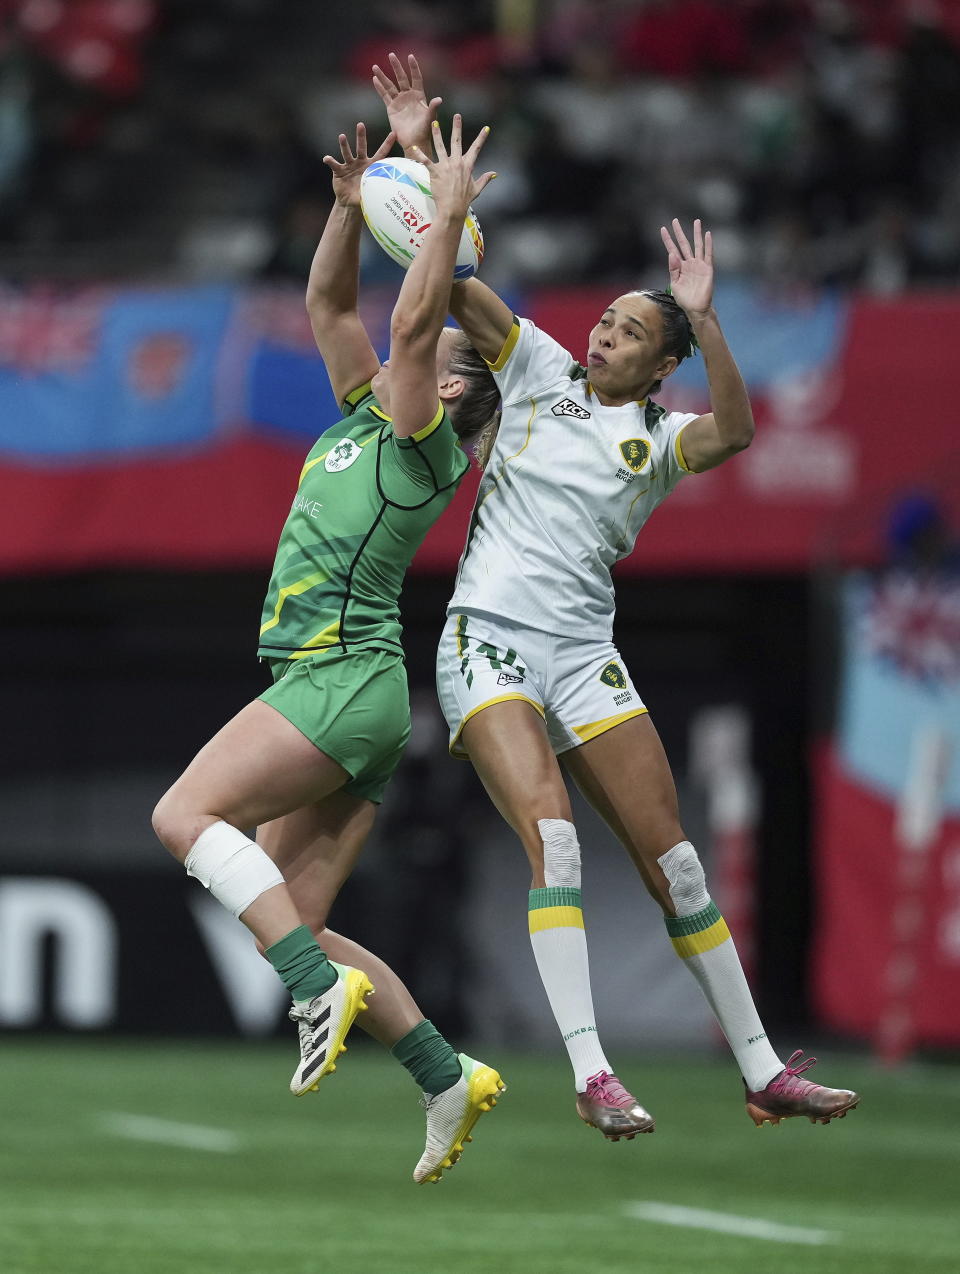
[0,287,233,465]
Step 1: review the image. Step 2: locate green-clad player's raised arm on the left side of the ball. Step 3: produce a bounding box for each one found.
[307,124,395,403]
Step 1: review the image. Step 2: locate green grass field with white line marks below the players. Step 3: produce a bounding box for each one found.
[0,1038,960,1274]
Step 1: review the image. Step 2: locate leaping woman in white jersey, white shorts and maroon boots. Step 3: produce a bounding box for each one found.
[374,55,859,1140]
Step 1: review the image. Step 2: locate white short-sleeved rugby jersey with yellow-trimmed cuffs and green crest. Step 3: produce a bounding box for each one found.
[447,319,696,640]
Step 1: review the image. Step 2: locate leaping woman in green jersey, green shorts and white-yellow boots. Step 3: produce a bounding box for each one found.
[153,117,502,1181]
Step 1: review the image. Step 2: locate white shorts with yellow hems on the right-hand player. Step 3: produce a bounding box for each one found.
[437,614,647,757]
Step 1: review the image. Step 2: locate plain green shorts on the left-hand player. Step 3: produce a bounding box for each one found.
[260,650,410,804]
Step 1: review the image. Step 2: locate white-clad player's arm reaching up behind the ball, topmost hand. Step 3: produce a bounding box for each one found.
[373,54,513,363]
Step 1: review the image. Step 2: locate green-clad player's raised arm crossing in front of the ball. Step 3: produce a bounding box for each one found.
[390,115,494,438]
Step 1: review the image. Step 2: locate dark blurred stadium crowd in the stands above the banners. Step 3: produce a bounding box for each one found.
[0,0,960,296]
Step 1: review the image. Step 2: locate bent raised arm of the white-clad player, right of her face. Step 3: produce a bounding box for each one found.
[660,218,755,473]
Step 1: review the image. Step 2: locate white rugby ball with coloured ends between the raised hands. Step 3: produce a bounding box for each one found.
[360,159,484,279]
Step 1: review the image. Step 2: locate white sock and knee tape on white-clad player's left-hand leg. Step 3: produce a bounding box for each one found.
[527,818,612,1093]
